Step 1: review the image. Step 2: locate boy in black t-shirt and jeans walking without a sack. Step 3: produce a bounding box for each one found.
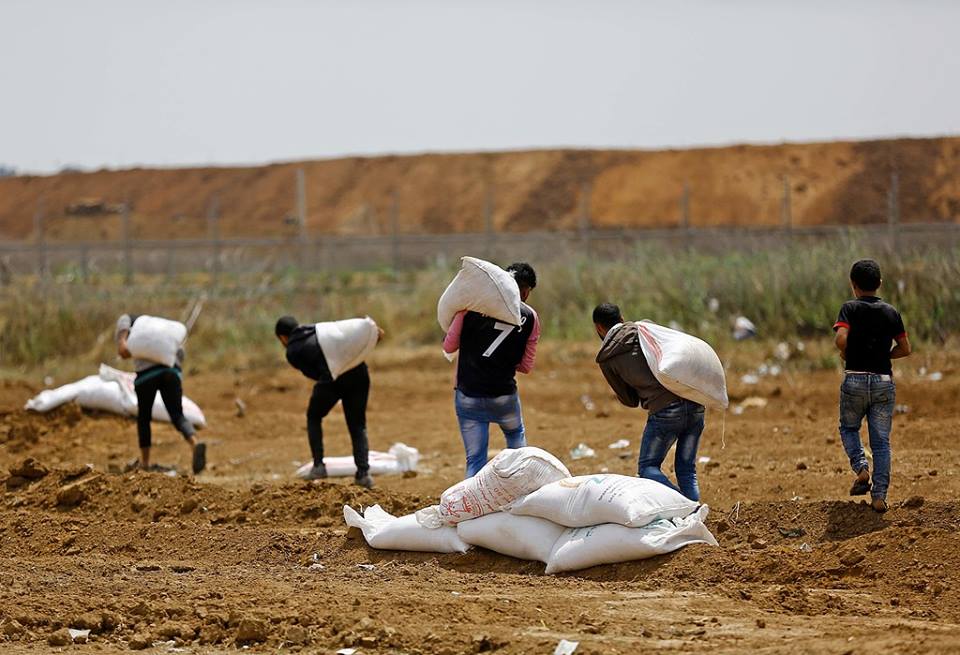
[833,259,911,512]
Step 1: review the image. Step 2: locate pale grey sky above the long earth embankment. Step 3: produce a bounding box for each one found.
[0,0,960,171]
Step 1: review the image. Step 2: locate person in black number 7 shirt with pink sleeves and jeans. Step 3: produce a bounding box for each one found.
[443,263,540,478]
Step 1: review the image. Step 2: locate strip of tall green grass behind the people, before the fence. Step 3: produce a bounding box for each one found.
[0,244,960,370]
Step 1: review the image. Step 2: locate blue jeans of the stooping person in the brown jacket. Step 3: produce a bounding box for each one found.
[637,400,704,501]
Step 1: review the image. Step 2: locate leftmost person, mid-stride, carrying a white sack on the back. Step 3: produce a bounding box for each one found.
[115,314,207,474]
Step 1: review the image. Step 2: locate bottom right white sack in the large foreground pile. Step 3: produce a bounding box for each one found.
[546,505,717,573]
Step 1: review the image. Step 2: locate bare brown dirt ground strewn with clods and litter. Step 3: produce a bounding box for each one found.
[0,345,960,655]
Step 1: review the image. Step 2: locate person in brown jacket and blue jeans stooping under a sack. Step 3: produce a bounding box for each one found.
[593,303,704,501]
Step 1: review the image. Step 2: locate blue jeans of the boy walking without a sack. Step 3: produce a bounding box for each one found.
[840,373,897,499]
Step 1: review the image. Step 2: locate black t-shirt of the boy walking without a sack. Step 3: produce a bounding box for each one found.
[833,296,906,375]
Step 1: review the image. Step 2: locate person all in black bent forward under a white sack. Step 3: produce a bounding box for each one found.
[275,316,383,489]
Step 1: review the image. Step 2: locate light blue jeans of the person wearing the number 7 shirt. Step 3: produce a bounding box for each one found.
[454,389,527,478]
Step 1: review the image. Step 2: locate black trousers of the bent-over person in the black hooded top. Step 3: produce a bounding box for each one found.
[307,364,370,477]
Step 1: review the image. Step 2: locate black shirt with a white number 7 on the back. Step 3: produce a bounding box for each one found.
[457,303,535,398]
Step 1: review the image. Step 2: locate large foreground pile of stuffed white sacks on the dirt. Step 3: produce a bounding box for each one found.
[343,447,717,573]
